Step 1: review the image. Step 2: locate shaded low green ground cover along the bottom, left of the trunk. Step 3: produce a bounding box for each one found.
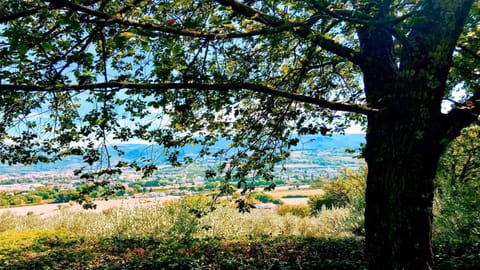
[0,231,365,269]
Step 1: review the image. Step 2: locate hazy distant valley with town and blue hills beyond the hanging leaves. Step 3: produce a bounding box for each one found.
[0,135,364,206]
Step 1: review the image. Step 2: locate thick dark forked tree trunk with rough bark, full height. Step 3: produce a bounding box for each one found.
[358,1,474,270]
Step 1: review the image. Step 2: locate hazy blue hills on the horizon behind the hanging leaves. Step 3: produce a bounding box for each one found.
[0,134,365,176]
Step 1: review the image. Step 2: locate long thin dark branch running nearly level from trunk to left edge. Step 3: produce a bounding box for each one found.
[0,82,379,114]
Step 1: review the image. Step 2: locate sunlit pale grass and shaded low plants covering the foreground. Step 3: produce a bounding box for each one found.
[0,191,480,269]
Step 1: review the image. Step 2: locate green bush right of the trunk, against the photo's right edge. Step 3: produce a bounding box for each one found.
[434,126,480,246]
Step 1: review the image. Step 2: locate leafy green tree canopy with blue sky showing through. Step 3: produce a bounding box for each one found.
[0,1,479,179]
